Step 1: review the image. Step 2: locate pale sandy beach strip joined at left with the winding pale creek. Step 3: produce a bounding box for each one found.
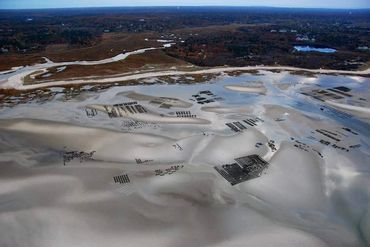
[0,43,370,91]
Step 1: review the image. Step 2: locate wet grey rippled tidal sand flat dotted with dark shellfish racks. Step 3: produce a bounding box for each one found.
[0,71,370,247]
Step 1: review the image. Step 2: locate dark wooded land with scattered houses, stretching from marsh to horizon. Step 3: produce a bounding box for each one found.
[0,7,370,70]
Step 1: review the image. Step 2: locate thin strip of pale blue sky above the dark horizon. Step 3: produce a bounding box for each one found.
[0,0,370,9]
